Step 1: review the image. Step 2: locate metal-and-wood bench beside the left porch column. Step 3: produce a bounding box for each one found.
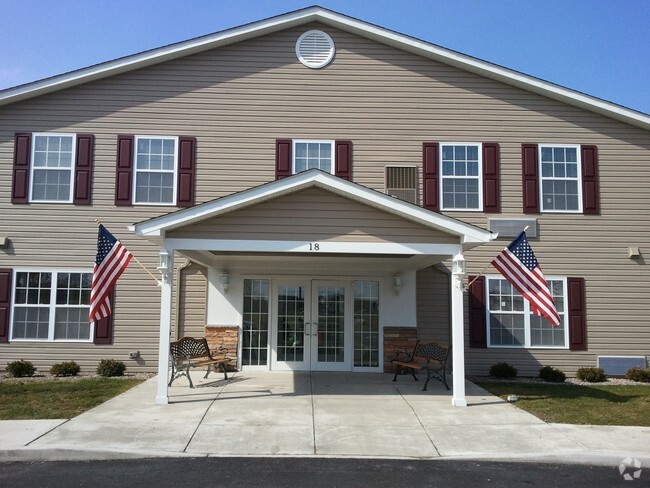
[169,337,231,388]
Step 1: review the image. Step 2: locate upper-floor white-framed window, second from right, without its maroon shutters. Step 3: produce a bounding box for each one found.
[440,144,483,210]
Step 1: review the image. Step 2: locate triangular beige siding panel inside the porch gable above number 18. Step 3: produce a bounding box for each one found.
[168,188,458,244]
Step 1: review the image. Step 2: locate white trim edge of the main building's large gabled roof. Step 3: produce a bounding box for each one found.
[0,6,650,129]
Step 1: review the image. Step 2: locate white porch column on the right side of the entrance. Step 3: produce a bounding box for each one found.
[451,252,467,407]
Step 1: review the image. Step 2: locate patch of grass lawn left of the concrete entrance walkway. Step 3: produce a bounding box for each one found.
[0,377,144,420]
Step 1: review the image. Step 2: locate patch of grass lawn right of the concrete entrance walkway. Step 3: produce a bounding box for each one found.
[477,382,650,426]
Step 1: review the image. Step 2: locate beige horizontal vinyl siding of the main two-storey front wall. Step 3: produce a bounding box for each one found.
[0,24,650,374]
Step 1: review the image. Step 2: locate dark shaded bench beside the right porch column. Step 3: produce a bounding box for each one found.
[391,340,451,391]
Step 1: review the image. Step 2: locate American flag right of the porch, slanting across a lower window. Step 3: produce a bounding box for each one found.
[492,232,560,327]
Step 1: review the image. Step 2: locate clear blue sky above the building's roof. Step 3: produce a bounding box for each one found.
[0,0,650,113]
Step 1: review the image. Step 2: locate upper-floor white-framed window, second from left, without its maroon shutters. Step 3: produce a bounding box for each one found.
[133,136,178,205]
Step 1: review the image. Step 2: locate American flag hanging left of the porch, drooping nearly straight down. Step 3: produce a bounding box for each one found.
[89,224,133,322]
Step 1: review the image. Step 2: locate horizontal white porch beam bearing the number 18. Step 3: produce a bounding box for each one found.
[165,238,459,257]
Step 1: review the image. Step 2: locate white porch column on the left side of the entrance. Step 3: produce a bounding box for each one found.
[156,249,174,405]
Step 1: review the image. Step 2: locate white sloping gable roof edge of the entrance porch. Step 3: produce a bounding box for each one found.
[129,169,497,249]
